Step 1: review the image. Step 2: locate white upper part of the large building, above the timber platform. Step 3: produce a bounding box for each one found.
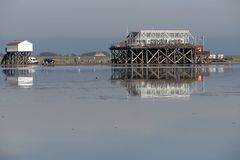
[127,30,194,46]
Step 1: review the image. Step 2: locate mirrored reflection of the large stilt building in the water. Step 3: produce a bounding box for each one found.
[111,66,209,98]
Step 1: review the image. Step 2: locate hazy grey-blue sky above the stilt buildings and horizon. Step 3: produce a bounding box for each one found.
[0,0,240,55]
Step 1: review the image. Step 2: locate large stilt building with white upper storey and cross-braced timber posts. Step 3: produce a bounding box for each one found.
[110,30,209,64]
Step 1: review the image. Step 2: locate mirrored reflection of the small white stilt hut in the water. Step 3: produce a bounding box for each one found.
[2,68,34,88]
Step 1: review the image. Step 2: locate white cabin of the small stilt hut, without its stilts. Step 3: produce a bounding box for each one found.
[6,40,33,52]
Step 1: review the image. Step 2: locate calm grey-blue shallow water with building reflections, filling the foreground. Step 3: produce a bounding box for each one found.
[0,65,240,160]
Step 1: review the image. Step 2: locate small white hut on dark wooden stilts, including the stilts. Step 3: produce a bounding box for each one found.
[1,40,33,65]
